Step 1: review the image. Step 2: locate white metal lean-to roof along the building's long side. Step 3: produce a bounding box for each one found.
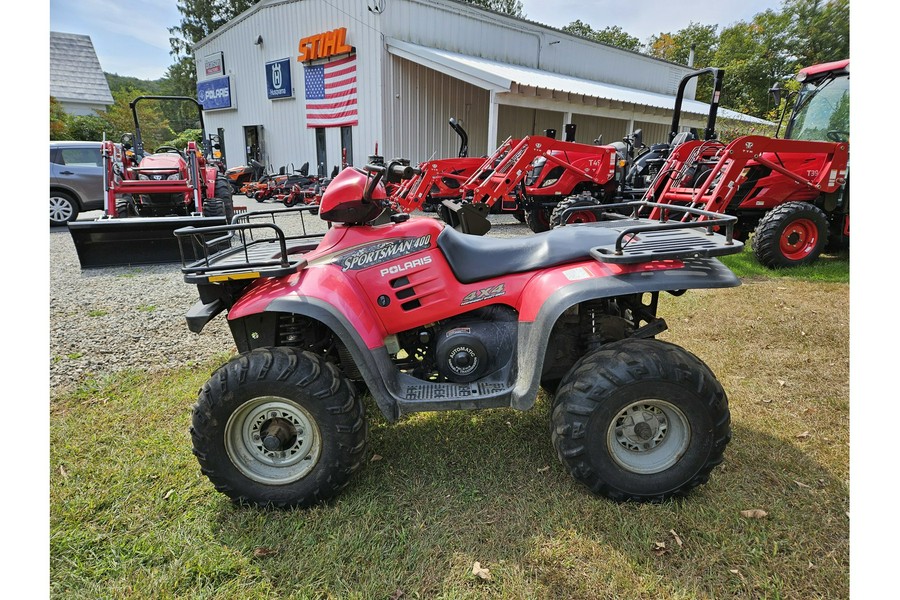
[387,39,769,124]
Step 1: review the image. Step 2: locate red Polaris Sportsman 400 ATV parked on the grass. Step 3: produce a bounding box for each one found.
[176,157,741,507]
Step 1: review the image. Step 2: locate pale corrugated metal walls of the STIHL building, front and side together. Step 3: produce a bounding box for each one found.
[195,0,708,172]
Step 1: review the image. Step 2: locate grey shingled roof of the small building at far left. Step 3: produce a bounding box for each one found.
[50,31,114,104]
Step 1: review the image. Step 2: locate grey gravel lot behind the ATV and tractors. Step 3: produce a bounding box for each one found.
[50,202,530,396]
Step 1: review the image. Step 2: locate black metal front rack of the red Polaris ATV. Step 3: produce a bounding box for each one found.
[174,206,323,284]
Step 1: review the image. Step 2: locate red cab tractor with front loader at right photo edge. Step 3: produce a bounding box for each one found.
[645,60,850,268]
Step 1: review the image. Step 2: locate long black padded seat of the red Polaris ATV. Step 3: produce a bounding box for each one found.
[437,224,619,283]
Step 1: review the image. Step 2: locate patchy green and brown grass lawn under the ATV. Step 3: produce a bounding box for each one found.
[49,257,850,599]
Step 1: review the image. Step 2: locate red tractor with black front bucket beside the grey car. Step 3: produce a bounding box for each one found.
[69,96,234,268]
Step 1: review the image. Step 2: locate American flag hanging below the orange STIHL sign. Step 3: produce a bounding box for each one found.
[303,55,358,128]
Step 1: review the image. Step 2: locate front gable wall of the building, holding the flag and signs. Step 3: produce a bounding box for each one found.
[195,0,384,172]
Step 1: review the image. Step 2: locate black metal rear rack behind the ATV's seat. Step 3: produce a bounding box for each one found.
[560,200,744,264]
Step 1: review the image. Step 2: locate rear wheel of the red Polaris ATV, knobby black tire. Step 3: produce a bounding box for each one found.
[551,338,731,502]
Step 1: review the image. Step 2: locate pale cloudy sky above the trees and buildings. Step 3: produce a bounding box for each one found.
[50,0,781,79]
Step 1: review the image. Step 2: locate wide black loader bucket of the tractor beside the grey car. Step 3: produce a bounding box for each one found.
[69,217,227,269]
